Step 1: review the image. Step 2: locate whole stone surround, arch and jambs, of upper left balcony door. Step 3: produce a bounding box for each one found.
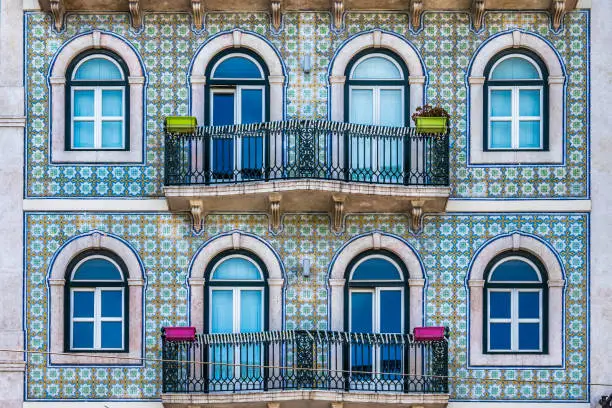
[189,29,285,125]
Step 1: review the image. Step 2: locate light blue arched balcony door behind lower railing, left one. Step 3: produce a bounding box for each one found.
[208,254,266,391]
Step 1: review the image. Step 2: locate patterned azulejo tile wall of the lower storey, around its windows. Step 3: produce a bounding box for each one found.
[25,213,589,400]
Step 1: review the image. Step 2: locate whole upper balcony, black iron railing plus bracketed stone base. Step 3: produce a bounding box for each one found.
[164,121,449,230]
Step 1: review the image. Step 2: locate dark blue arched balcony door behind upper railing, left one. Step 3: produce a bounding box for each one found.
[207,51,268,182]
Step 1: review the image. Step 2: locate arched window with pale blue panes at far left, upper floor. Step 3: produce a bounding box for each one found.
[66,50,130,150]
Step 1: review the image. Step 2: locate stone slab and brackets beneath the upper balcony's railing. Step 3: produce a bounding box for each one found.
[164,179,450,233]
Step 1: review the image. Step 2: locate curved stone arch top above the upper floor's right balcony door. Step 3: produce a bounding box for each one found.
[330,30,425,78]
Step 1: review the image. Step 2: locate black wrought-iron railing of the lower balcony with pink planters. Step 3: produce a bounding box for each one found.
[162,330,448,394]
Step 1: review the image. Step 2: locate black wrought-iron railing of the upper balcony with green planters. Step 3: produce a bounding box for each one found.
[165,120,448,186]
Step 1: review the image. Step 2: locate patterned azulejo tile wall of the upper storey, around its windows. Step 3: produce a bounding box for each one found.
[25,11,589,198]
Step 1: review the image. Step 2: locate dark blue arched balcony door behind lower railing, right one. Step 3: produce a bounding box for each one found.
[345,251,408,381]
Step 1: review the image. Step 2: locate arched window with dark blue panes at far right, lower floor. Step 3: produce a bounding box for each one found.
[484,252,547,353]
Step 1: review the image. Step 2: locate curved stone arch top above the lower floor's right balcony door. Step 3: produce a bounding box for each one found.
[329,232,425,286]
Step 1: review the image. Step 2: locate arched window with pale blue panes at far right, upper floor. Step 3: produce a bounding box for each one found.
[484,50,548,150]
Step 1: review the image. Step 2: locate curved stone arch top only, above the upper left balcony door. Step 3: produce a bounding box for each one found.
[190,29,284,78]
